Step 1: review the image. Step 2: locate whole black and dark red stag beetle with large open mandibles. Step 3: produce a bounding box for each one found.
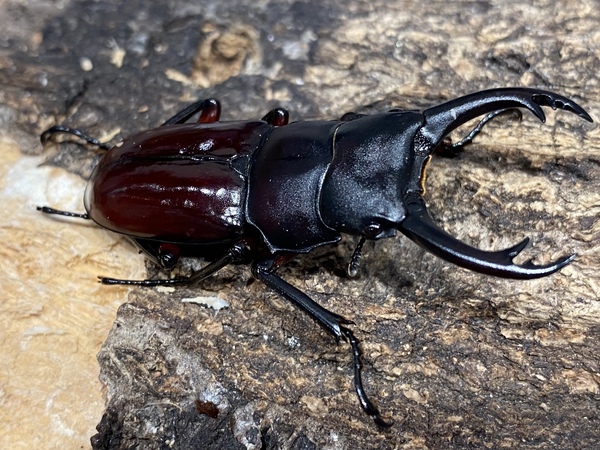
[38,88,592,426]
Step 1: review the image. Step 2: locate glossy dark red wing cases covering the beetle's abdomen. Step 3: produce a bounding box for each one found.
[85,122,271,243]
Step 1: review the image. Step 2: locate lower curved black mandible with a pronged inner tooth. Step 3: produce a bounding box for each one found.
[398,198,575,280]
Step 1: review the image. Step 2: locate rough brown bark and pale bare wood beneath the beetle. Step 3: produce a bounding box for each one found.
[0,0,600,449]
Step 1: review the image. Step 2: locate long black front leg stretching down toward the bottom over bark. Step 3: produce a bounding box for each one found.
[252,255,393,427]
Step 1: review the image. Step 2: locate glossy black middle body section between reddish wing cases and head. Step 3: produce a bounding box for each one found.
[246,121,341,253]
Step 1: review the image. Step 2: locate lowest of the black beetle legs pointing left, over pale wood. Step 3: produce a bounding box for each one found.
[98,239,252,287]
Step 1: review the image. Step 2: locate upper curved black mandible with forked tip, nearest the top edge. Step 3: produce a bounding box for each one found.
[415,88,593,154]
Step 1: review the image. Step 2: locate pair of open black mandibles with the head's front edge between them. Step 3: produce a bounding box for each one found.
[398,88,592,279]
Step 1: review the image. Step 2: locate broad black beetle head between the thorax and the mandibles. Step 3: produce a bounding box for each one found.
[319,111,423,238]
